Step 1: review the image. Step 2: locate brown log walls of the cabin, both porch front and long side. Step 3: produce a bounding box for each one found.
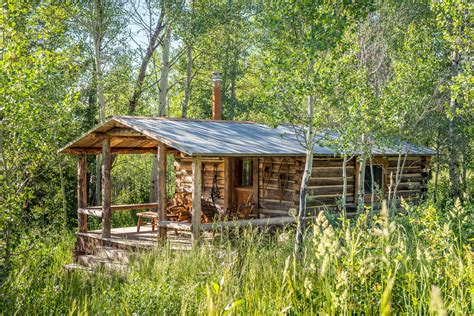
[175,156,429,216]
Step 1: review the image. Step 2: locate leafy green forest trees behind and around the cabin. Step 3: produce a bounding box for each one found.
[0,0,474,314]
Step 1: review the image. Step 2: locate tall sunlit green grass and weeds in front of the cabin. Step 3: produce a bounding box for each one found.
[0,204,473,315]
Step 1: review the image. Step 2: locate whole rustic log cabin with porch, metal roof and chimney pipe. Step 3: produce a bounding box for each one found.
[60,73,435,253]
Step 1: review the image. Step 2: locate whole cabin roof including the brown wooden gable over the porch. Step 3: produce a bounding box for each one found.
[59,116,435,156]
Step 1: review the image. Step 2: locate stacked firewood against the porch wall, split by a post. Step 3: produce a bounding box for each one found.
[166,192,218,223]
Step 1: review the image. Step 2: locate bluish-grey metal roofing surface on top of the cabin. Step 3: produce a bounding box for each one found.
[61,116,435,156]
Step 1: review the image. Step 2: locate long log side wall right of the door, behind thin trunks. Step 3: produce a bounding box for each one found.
[259,156,429,216]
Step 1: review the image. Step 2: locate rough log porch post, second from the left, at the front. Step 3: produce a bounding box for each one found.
[102,137,112,238]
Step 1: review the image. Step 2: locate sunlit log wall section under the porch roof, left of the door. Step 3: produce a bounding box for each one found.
[174,158,224,210]
